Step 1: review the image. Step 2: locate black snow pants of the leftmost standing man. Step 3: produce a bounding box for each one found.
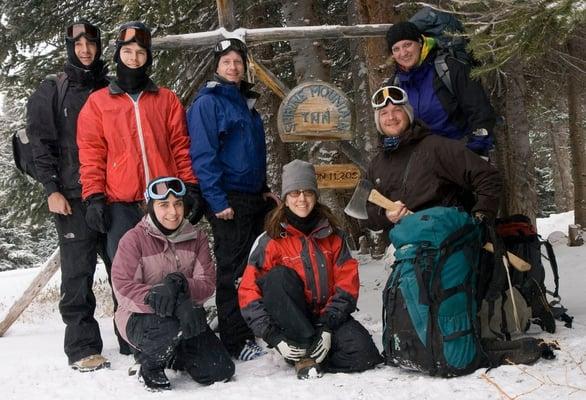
[55,198,112,364]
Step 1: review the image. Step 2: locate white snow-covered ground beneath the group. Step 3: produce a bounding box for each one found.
[0,213,586,400]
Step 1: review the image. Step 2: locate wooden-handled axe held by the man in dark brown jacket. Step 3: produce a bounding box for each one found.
[344,179,531,272]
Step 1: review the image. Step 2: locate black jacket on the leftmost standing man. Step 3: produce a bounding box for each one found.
[27,63,107,199]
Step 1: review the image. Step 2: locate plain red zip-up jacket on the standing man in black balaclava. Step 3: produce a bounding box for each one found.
[77,83,197,203]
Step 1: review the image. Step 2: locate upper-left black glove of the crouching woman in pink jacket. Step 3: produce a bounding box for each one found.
[145,272,188,318]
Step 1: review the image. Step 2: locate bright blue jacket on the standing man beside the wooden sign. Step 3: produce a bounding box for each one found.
[187,80,266,213]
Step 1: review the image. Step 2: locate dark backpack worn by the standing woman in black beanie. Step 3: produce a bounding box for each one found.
[409,7,477,94]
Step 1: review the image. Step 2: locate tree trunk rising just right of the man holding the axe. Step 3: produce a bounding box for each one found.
[497,60,538,222]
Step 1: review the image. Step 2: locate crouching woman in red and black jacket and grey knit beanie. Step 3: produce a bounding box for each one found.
[238,160,382,379]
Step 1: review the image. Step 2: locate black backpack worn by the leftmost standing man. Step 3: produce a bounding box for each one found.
[12,72,69,181]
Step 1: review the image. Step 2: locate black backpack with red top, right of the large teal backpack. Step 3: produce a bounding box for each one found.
[478,214,573,339]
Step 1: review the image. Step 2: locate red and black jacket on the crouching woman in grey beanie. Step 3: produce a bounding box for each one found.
[238,220,360,337]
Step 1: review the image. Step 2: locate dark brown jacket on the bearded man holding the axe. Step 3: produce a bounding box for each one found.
[365,125,502,230]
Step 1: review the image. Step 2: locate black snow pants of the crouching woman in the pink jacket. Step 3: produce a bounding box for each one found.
[126,314,235,385]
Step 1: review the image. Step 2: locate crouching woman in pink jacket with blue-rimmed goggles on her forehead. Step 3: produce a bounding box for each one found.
[112,177,234,390]
